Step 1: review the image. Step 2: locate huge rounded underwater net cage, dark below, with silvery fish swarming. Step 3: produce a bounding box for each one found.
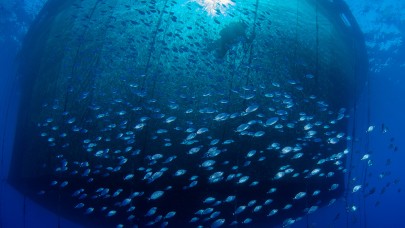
[10,0,366,227]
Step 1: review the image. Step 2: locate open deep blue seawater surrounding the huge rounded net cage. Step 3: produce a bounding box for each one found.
[0,0,405,228]
